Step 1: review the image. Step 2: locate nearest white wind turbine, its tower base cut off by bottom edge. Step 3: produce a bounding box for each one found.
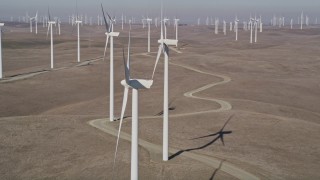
[113,31,157,180]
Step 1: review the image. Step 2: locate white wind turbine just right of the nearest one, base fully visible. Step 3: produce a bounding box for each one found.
[152,6,178,161]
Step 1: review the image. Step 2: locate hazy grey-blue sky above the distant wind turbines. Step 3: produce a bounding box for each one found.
[0,0,320,20]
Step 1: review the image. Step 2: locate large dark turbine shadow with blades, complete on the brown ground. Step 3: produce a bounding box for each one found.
[169,115,234,160]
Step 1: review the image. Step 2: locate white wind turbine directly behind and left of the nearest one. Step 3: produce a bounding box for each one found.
[101,4,120,121]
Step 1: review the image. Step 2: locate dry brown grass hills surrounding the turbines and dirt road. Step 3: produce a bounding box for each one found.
[0,24,320,180]
